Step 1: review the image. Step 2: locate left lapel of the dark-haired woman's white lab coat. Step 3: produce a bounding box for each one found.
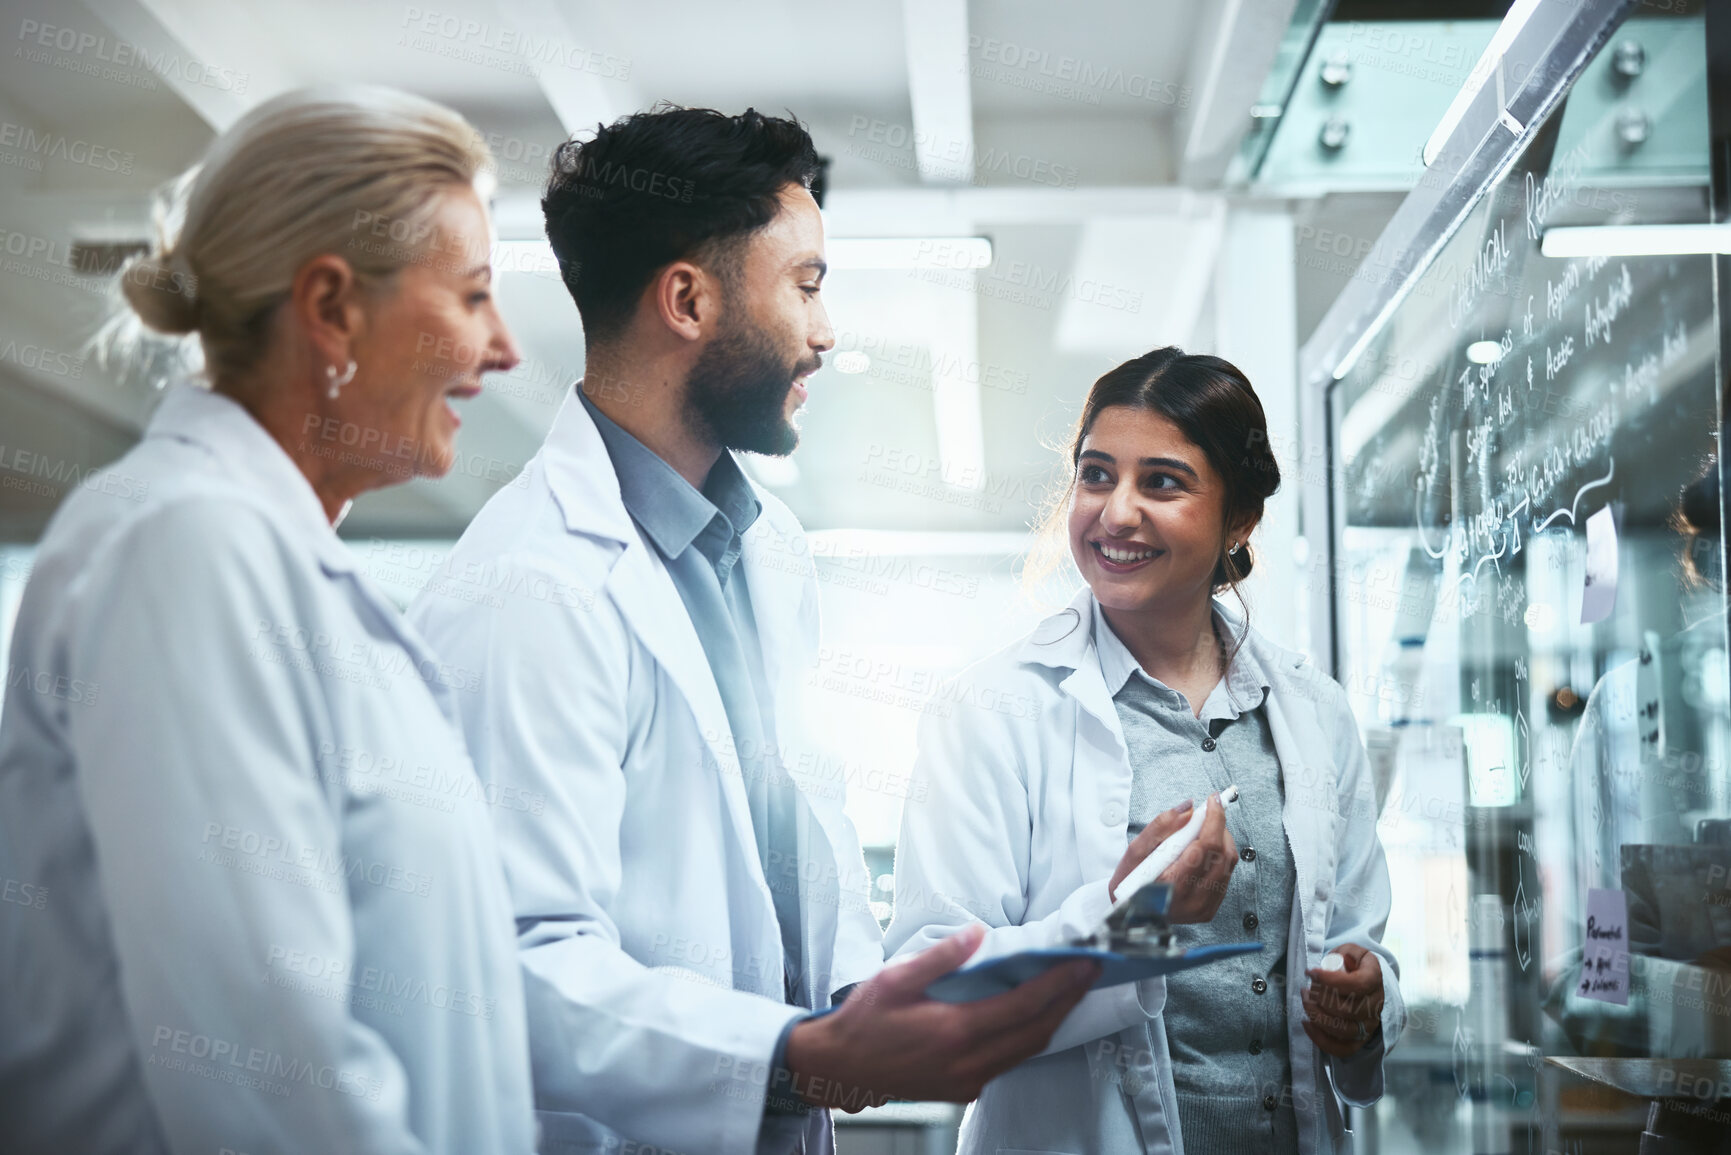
[1018,587,1130,878]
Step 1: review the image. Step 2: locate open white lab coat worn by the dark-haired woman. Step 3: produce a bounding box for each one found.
[886,589,1406,1155]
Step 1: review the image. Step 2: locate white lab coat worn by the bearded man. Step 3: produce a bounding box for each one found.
[410,390,883,1155]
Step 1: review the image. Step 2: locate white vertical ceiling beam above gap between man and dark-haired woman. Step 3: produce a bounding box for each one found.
[902,0,975,185]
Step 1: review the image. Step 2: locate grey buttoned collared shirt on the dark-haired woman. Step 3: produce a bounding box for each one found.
[1094,601,1298,1155]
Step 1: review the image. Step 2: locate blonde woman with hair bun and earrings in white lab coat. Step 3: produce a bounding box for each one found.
[0,88,533,1155]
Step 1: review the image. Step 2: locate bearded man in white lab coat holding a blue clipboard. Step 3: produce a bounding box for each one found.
[410,107,1096,1155]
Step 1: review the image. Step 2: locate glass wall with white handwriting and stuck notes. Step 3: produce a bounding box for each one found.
[1328,7,1731,1152]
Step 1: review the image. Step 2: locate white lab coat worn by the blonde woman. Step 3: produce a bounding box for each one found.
[0,386,535,1155]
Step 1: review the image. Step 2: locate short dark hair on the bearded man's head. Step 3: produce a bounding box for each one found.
[542,104,820,345]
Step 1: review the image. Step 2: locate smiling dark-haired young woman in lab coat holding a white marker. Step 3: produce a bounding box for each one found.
[886,348,1406,1155]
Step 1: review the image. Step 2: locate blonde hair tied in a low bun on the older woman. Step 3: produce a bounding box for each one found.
[95,85,493,384]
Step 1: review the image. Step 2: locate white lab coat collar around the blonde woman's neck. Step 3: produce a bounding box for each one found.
[144,384,355,573]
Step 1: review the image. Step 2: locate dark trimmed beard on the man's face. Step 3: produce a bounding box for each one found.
[685,310,824,457]
